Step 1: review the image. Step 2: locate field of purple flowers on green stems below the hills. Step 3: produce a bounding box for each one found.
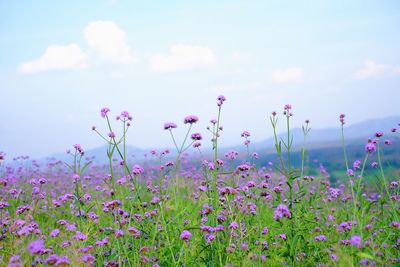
[0,96,400,267]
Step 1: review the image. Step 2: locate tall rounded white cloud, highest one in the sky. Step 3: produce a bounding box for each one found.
[83,21,135,64]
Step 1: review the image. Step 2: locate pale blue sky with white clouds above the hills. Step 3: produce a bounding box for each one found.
[0,0,400,157]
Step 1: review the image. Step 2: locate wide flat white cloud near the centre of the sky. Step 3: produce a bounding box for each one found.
[150,44,217,72]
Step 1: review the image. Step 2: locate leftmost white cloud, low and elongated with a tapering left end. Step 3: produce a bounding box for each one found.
[20,44,87,73]
